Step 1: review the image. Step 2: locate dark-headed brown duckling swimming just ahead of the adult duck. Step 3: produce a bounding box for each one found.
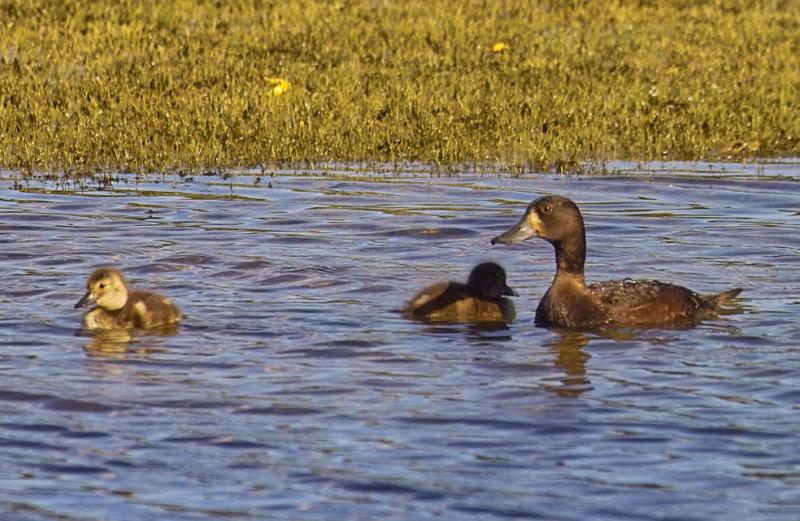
[403,262,517,322]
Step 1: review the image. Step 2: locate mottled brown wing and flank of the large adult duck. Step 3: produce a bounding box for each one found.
[588,279,710,325]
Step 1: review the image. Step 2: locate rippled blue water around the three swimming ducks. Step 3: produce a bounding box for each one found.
[0,162,800,521]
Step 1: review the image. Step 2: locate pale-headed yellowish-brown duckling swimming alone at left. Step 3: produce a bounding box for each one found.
[75,268,182,329]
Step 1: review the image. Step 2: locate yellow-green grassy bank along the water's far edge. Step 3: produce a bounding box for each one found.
[0,0,800,174]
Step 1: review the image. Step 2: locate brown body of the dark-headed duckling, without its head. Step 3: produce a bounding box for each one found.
[403,282,515,322]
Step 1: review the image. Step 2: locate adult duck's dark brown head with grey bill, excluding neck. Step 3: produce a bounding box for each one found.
[492,195,584,244]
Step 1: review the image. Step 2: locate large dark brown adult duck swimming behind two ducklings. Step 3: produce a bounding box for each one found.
[492,196,742,329]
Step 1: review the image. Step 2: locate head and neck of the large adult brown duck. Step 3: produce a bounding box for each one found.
[492,195,586,274]
